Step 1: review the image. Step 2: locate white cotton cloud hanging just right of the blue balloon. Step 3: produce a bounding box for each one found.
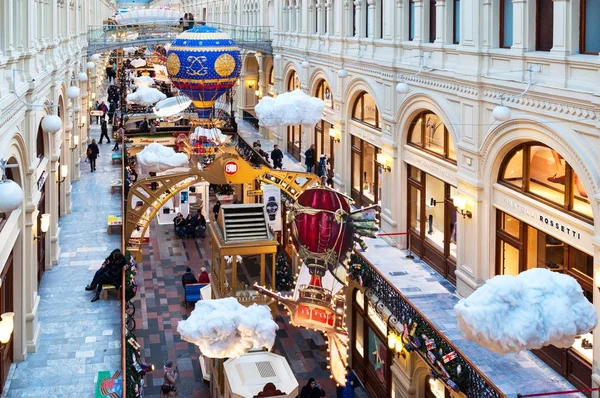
[254,90,325,127]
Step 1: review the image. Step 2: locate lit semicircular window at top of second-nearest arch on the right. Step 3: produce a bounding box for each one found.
[408,111,456,163]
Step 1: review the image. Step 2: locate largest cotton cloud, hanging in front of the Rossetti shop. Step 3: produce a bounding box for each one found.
[454,268,598,354]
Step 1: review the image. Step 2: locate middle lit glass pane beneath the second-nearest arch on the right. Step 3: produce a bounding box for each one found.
[425,175,445,251]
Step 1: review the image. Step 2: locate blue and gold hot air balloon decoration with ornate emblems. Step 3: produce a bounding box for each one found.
[167,25,241,119]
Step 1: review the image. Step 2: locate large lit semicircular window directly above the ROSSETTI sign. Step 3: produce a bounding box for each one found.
[498,142,593,222]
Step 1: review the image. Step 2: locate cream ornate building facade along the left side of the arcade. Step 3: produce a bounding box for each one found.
[0,0,115,383]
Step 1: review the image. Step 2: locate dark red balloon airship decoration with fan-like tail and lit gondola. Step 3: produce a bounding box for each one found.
[254,186,379,383]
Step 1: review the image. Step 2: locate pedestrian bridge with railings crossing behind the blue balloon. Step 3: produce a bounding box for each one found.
[87,21,273,56]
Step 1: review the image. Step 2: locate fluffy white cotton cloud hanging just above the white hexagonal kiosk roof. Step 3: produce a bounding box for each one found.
[177,297,278,358]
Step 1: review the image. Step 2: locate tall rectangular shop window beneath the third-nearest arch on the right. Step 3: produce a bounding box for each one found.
[351,136,381,206]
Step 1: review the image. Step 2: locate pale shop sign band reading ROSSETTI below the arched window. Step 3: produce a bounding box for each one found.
[494,188,592,252]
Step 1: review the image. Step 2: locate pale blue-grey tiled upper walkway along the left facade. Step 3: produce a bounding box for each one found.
[3,125,121,398]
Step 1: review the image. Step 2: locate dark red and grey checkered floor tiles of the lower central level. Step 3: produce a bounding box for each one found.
[134,222,335,398]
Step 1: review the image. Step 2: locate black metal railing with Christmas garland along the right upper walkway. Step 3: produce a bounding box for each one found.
[354,252,506,398]
